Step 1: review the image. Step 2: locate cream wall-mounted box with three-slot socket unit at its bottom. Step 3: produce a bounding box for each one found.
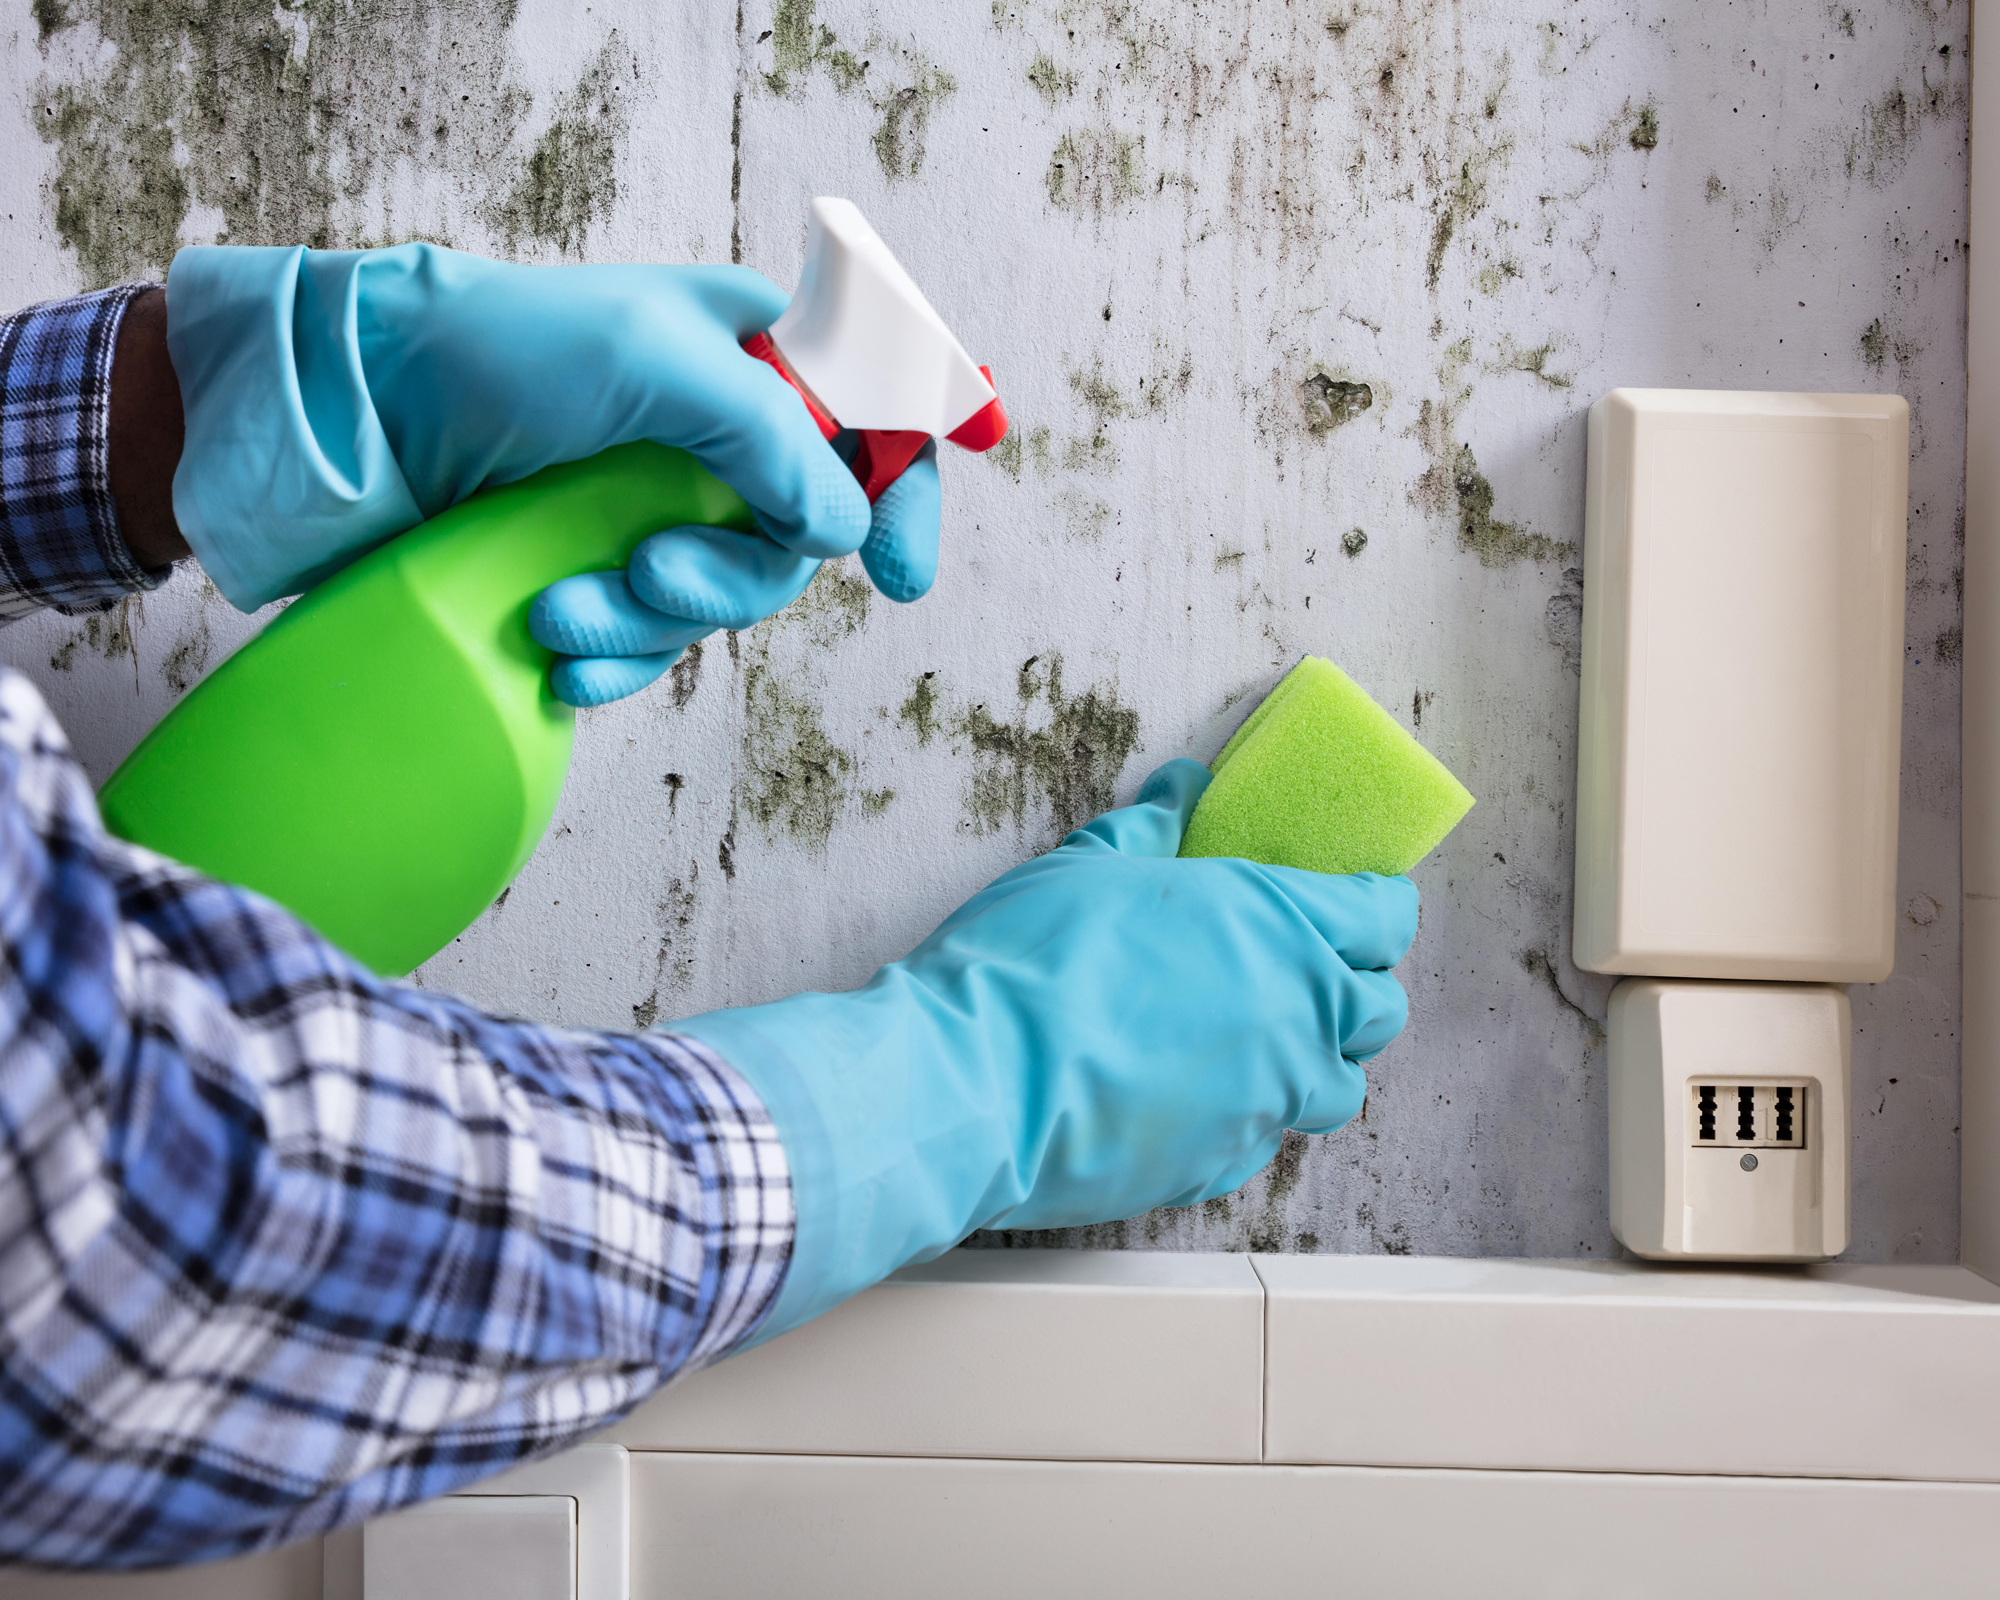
[1574,388,1910,1260]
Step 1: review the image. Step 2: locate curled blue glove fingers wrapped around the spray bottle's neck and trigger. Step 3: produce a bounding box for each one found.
[528,440,940,706]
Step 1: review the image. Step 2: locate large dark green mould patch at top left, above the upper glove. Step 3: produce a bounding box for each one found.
[34,0,548,286]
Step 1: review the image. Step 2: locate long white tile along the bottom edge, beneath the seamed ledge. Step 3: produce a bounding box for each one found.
[632,1454,2000,1600]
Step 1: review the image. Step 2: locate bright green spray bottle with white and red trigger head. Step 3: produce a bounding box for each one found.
[98,200,1006,976]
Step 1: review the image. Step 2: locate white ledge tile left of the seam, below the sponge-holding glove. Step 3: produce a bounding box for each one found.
[606,1250,1264,1462]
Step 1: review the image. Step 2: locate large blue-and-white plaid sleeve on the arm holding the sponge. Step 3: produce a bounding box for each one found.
[0,672,792,1566]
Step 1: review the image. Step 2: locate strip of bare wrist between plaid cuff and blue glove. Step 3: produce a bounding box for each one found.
[110,288,192,568]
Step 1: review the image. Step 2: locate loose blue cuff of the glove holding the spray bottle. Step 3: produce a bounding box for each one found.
[166,246,422,612]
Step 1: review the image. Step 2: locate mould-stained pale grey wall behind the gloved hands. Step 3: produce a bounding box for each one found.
[0,0,1968,1260]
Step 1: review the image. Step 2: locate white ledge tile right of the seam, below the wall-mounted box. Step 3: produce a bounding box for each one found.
[1252,1256,2000,1482]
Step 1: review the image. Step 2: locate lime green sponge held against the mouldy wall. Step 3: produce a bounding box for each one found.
[1180,656,1472,876]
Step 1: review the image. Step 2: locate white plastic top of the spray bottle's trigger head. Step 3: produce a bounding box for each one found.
[770,198,996,438]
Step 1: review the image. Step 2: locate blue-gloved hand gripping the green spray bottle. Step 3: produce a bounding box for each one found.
[166,244,936,650]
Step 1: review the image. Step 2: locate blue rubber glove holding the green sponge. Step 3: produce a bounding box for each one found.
[672,760,1416,1338]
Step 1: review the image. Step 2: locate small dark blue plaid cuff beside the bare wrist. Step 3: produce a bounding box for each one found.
[0,284,172,622]
